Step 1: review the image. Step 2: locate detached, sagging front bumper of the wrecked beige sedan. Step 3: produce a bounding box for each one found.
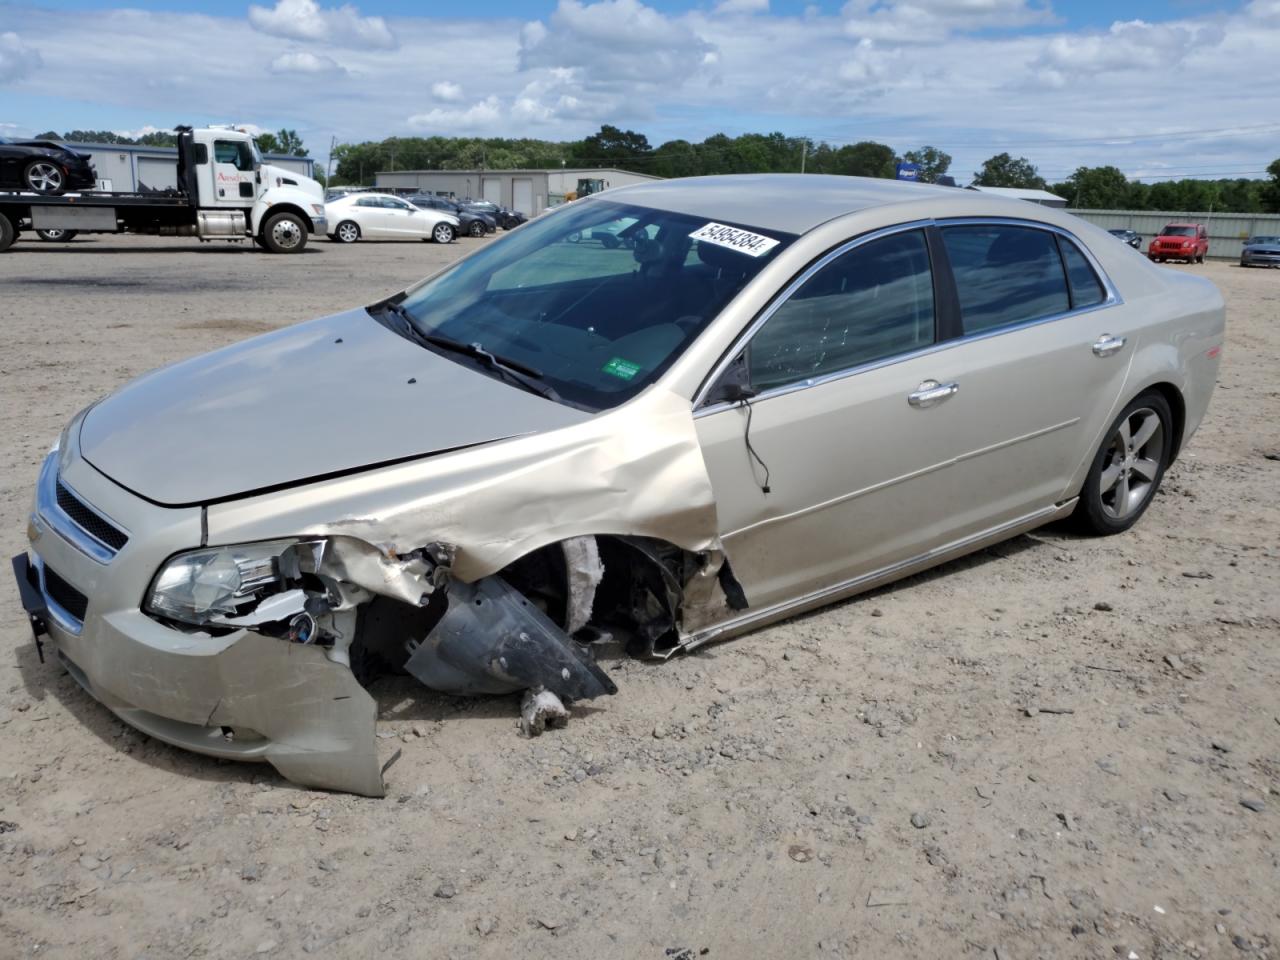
[13,454,384,796]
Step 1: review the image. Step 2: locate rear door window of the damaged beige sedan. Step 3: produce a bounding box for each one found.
[942,224,1071,334]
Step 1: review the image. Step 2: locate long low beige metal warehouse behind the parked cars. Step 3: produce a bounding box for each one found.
[374,166,660,216]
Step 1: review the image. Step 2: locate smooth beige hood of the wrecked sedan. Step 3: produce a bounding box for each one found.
[79,310,591,506]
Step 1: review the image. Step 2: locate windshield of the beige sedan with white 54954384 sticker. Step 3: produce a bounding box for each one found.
[391,201,792,410]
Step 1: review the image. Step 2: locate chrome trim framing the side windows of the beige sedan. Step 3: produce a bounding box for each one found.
[694,216,1124,417]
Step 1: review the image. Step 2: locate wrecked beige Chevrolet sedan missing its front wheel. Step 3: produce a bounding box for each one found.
[14,175,1224,795]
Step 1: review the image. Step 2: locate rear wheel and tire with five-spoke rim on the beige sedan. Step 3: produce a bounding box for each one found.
[1071,390,1174,536]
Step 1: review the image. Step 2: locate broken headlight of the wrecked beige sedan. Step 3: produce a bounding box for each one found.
[143,540,324,626]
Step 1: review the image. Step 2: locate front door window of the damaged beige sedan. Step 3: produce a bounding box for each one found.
[748,230,934,390]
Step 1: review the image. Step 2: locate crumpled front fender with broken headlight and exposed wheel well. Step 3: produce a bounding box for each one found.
[131,390,746,795]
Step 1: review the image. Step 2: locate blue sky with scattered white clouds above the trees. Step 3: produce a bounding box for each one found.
[0,0,1280,180]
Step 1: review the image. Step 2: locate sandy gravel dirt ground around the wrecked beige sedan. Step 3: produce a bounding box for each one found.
[0,238,1280,960]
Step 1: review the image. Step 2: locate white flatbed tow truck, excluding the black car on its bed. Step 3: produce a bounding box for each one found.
[0,127,326,253]
